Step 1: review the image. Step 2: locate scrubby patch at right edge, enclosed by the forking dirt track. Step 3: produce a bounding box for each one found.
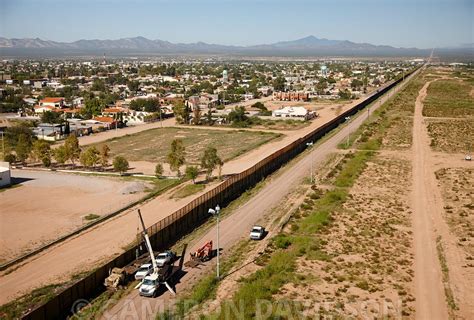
[436,167,474,258]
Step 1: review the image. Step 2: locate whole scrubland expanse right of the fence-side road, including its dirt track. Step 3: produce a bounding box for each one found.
[153,67,474,319]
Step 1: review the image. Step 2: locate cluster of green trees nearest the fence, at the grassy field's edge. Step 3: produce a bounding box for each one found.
[155,139,224,183]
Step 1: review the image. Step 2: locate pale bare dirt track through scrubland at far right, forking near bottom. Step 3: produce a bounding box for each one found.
[412,81,474,319]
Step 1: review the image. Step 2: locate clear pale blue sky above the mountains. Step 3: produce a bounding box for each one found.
[0,0,474,48]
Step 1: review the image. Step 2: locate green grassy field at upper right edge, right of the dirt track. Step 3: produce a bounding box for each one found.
[423,79,474,118]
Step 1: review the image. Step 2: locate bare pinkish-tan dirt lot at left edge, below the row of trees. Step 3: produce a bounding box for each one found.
[0,170,147,262]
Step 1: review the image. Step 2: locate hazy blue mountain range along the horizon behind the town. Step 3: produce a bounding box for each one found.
[0,36,472,56]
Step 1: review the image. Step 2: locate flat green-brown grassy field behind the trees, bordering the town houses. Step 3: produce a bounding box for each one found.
[90,127,279,164]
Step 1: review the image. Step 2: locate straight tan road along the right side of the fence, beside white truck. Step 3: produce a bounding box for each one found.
[103,71,413,320]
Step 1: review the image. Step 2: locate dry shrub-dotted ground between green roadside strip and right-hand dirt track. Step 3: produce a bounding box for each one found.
[275,156,414,319]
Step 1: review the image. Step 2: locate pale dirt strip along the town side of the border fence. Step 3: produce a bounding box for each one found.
[0,80,408,316]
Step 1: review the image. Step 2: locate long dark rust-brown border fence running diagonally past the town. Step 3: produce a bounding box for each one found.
[23,70,415,320]
